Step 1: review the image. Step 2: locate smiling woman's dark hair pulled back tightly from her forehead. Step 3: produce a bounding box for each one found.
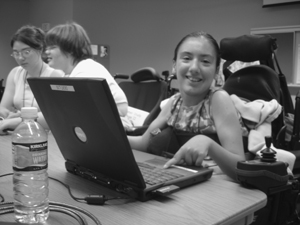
[173,31,221,68]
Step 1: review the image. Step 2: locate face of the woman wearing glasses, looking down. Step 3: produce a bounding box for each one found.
[12,41,42,70]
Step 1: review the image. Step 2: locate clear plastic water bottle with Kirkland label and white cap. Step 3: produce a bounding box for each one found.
[12,107,49,223]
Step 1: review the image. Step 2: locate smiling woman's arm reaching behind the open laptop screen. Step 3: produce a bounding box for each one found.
[128,100,172,152]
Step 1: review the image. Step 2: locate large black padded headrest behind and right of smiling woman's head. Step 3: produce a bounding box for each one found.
[220,35,277,62]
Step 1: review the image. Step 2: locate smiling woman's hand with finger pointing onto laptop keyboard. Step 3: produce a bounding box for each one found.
[164,135,213,168]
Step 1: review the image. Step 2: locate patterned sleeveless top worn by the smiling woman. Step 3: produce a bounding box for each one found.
[167,89,248,136]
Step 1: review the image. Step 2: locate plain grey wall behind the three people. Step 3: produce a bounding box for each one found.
[0,0,300,82]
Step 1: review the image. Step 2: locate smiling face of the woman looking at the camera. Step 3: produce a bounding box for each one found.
[173,36,217,99]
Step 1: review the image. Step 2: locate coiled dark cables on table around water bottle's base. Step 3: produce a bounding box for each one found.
[0,202,101,225]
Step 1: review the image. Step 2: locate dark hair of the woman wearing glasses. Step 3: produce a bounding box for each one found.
[10,25,45,51]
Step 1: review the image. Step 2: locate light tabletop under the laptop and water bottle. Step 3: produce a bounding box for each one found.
[0,134,267,225]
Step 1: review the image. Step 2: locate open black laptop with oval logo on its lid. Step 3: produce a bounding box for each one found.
[28,77,213,201]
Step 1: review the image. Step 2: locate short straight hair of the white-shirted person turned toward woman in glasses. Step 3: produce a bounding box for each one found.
[46,22,92,64]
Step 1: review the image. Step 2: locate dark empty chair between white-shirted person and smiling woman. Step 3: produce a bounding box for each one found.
[114,67,168,135]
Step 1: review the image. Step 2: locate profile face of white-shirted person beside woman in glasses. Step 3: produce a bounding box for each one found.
[46,45,70,73]
